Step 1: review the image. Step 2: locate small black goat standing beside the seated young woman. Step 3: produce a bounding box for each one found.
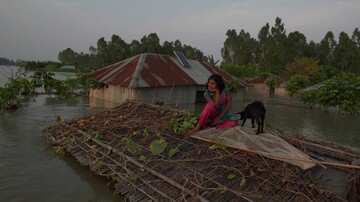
[237,101,266,134]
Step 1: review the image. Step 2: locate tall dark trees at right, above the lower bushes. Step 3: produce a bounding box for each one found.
[221,17,360,74]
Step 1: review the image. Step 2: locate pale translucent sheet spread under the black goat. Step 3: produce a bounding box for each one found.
[192,126,316,170]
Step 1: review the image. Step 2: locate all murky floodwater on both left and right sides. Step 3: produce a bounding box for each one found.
[0,66,360,201]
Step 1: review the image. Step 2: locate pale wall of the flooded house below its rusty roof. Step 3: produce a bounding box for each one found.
[90,85,245,105]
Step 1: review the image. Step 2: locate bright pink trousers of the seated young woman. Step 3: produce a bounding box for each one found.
[199,103,237,128]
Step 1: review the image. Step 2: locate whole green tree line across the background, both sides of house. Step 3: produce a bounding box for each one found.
[0,17,360,114]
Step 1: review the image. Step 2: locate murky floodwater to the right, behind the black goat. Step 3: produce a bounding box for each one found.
[181,88,360,152]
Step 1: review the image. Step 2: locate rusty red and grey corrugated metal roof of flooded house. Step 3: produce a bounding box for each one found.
[89,53,246,88]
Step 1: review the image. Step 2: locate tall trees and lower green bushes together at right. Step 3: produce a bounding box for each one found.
[221,17,360,114]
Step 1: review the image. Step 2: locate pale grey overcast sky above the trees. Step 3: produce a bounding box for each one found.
[0,0,360,61]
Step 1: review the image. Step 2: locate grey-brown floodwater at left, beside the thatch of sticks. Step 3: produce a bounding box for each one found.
[0,96,121,201]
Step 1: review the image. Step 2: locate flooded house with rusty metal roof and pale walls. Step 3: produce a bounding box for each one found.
[89,51,247,105]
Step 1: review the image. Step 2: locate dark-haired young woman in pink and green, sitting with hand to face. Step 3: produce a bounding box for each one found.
[187,74,237,135]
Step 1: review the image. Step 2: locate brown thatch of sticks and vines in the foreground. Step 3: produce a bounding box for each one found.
[43,101,360,201]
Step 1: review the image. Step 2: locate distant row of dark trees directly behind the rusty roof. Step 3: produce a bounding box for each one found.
[58,33,215,71]
